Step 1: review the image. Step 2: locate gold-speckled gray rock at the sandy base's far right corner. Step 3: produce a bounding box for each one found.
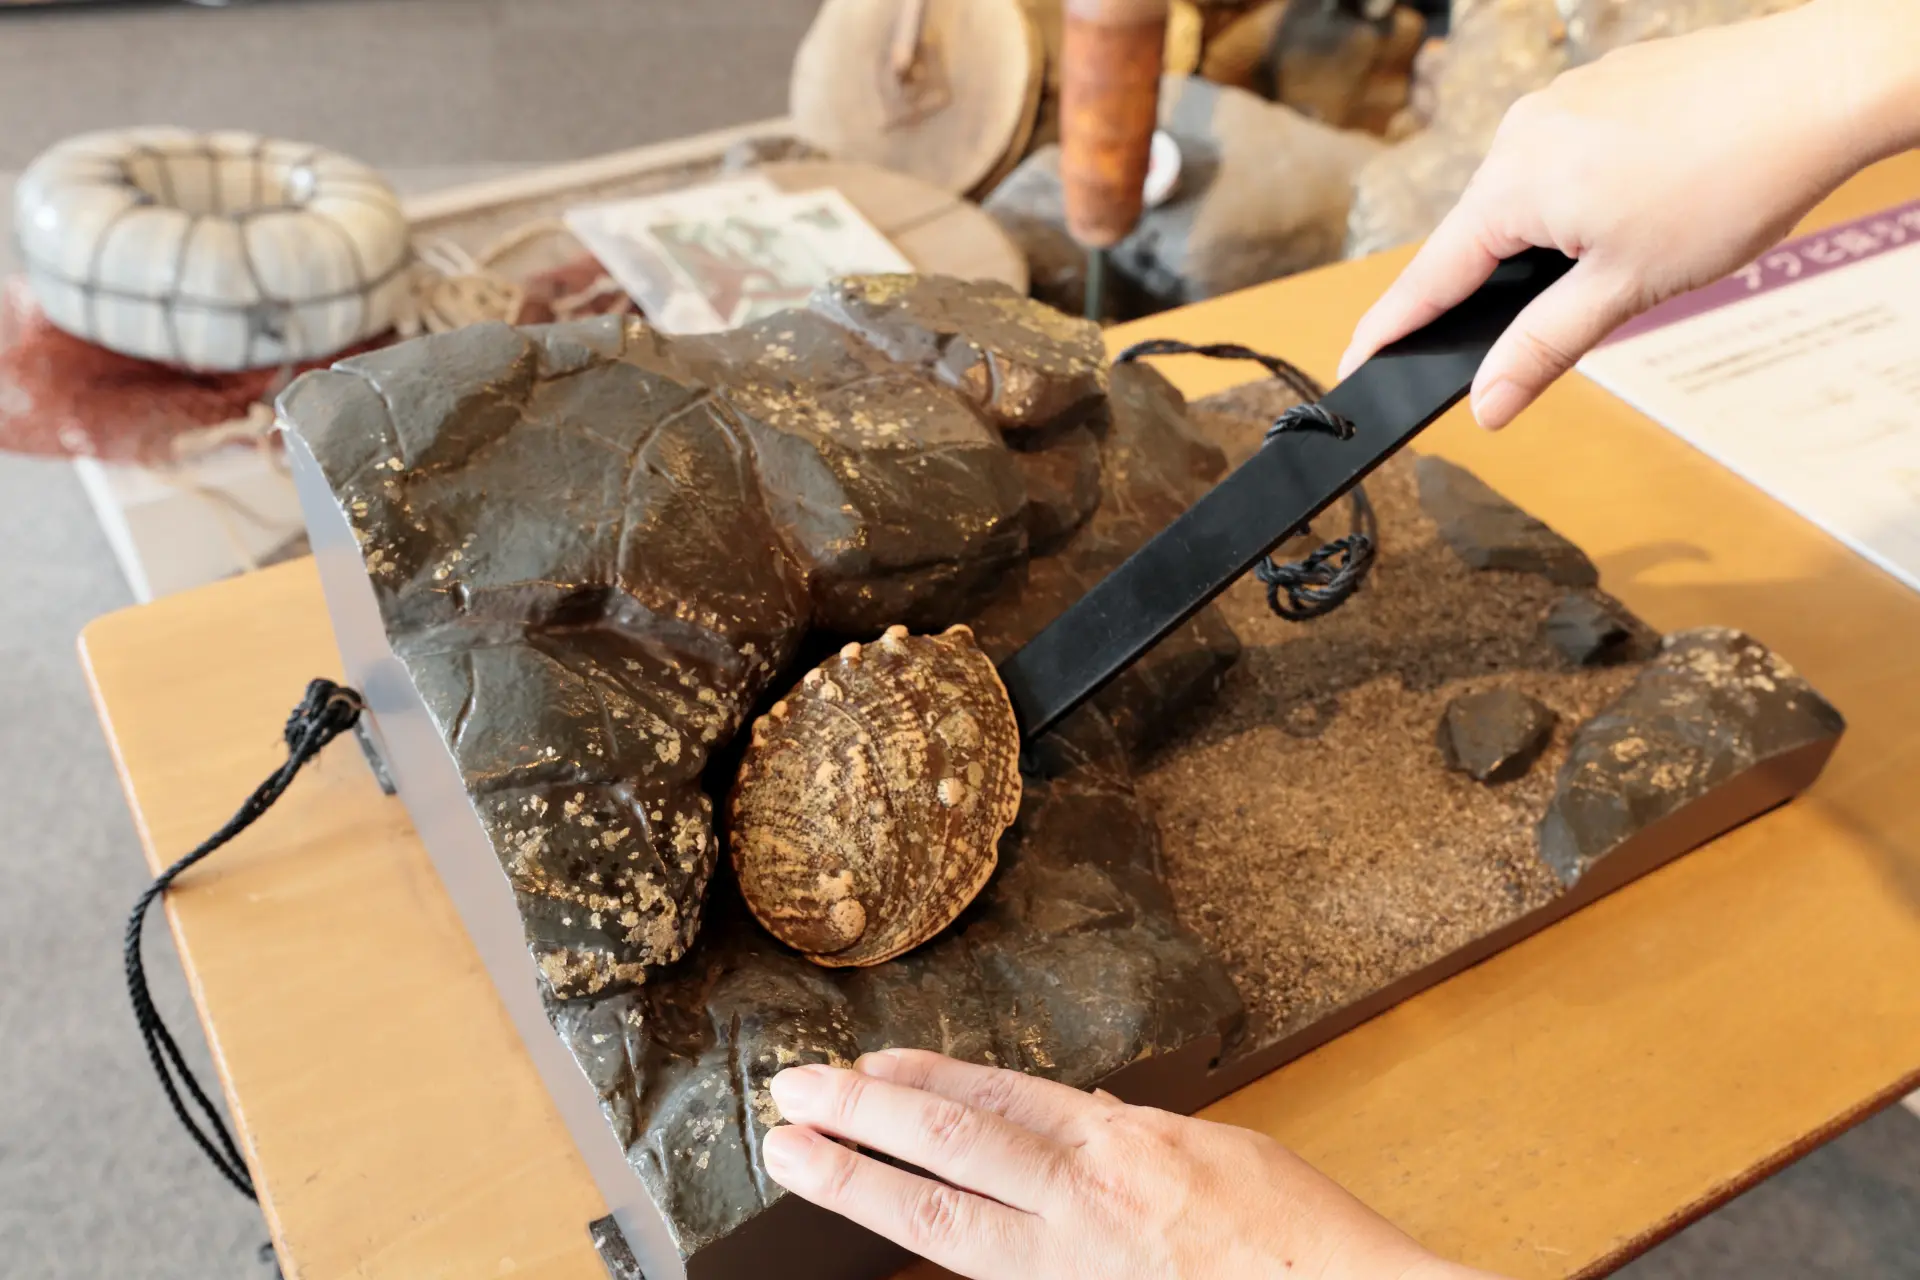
[1540,628,1845,887]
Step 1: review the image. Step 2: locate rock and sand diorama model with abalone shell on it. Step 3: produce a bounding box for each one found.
[280,276,1841,1276]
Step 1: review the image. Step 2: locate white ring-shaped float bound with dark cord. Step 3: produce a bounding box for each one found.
[13,129,411,370]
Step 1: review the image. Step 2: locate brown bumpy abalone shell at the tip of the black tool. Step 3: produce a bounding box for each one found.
[732,628,1020,967]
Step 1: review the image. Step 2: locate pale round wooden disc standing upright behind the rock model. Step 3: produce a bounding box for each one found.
[789,0,1044,194]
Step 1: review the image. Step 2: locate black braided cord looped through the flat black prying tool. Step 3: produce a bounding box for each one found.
[1114,338,1380,622]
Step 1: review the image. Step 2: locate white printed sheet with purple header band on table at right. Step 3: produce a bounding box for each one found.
[1580,201,1920,589]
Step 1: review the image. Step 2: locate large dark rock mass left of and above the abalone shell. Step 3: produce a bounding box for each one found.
[282,278,1106,1000]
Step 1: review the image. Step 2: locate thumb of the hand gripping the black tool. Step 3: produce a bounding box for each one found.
[1473,259,1634,432]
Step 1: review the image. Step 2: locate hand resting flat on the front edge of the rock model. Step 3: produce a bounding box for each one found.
[762,1050,1476,1280]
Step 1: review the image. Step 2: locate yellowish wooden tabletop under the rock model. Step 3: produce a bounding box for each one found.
[81,155,1920,1280]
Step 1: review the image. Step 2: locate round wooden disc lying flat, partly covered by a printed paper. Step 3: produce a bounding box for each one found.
[756,159,1027,294]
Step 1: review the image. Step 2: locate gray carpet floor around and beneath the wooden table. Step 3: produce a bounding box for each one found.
[0,0,1920,1280]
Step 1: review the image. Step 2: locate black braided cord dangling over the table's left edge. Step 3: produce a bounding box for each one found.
[125,679,363,1199]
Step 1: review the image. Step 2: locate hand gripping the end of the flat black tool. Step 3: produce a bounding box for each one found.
[1340,0,1920,428]
